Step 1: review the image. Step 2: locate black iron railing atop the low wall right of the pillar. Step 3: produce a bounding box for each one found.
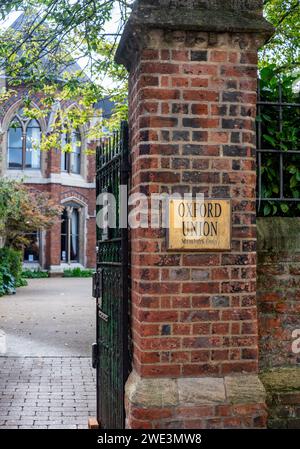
[257,84,300,216]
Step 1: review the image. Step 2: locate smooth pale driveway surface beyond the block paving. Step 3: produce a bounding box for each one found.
[0,278,96,357]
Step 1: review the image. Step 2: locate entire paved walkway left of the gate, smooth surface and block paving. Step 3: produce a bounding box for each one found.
[0,279,96,429]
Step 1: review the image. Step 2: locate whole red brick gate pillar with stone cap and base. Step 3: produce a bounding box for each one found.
[116,0,271,428]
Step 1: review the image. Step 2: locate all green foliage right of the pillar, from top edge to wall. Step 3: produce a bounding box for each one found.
[257,0,300,217]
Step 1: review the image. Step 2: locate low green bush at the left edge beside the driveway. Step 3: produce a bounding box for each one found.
[0,248,27,296]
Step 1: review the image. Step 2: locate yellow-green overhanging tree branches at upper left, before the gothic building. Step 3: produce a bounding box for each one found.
[0,0,130,135]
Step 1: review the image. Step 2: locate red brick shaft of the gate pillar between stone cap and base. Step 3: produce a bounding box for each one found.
[130,31,258,376]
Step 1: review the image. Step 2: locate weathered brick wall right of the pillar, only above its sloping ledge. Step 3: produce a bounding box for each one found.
[257,217,300,369]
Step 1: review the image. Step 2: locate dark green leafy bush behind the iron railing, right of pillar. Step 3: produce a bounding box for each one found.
[257,65,300,217]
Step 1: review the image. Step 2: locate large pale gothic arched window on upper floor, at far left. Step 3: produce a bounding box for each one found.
[7,109,41,170]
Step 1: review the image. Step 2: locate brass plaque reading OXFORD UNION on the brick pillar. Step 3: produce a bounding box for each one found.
[168,199,231,251]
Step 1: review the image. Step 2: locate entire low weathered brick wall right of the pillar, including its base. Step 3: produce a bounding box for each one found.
[257,217,300,429]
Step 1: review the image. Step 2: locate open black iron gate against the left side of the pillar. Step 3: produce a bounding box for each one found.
[93,122,129,429]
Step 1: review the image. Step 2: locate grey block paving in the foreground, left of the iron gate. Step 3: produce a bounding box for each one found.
[0,357,96,429]
